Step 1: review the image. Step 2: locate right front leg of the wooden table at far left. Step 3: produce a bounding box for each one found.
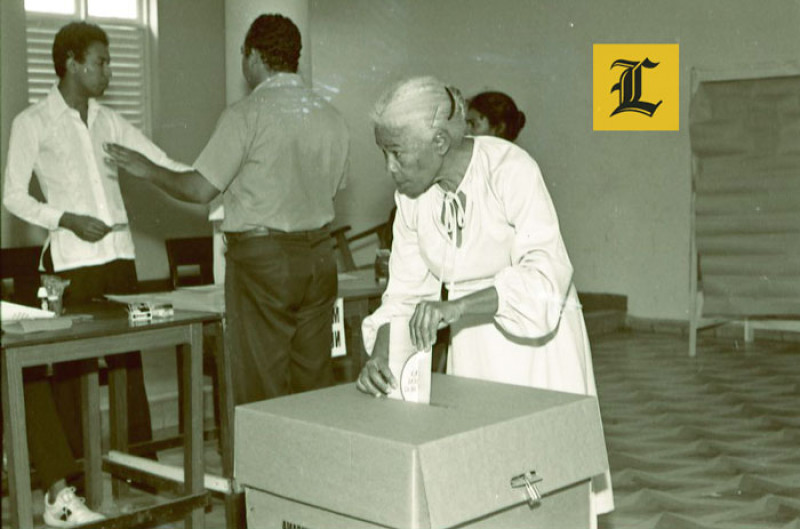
[178,323,205,529]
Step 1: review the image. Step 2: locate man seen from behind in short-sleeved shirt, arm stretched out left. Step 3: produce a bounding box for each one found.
[107,15,349,404]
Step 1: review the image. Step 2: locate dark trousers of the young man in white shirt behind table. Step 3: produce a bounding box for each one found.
[23,254,152,488]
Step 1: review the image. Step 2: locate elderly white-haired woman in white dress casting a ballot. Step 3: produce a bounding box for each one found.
[356,77,613,524]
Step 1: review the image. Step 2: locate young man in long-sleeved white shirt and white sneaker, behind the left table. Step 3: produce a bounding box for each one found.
[3,22,185,527]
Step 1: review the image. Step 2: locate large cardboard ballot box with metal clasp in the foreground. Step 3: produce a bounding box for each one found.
[235,374,608,529]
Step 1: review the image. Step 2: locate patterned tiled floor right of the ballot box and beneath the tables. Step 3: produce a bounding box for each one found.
[3,332,800,529]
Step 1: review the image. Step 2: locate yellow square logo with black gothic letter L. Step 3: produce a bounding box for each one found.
[592,44,680,130]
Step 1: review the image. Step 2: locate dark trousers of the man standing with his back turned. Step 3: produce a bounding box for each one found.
[225,229,338,404]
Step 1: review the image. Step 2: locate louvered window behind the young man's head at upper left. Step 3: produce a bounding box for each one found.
[25,0,151,132]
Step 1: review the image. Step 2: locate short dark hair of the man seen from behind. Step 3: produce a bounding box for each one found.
[244,14,302,73]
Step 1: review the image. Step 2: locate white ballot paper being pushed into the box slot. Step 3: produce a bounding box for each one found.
[388,318,432,404]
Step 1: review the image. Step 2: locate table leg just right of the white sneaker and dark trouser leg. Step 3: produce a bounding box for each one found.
[81,362,103,510]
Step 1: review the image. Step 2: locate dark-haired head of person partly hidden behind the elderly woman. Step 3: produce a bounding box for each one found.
[467,92,525,141]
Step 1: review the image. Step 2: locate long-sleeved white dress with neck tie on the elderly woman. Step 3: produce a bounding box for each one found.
[362,136,613,514]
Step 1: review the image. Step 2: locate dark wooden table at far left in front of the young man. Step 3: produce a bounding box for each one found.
[0,304,221,529]
